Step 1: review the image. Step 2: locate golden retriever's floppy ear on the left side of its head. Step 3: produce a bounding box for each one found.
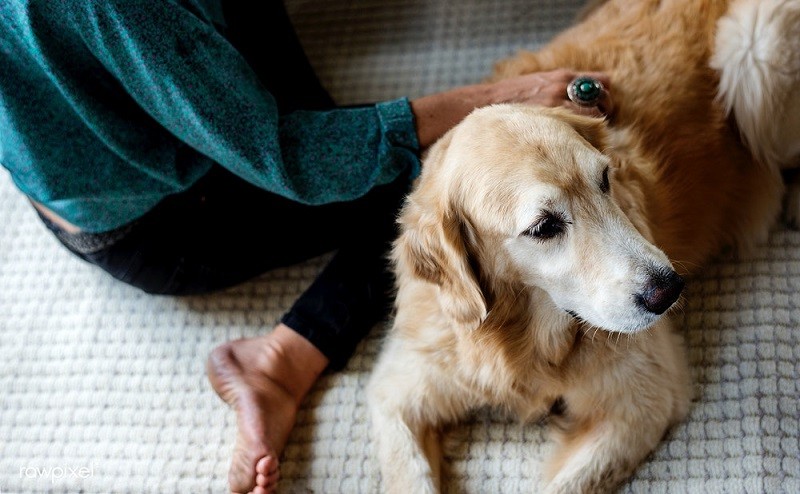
[393,136,487,330]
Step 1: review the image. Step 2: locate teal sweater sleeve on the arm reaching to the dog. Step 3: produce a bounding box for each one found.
[63,0,419,204]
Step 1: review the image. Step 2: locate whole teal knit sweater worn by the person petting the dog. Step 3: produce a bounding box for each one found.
[0,0,419,232]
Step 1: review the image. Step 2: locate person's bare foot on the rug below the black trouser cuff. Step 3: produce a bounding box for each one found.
[208,324,328,494]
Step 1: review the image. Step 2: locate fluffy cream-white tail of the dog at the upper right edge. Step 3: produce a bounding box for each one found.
[711,0,800,168]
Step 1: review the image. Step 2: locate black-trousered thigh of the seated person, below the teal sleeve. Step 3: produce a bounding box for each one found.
[76,167,408,295]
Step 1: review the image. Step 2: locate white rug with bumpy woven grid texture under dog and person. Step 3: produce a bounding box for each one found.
[0,0,800,494]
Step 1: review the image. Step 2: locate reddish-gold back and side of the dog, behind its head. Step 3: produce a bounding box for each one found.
[495,0,782,273]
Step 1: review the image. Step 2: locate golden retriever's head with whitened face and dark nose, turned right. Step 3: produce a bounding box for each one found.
[396,105,683,333]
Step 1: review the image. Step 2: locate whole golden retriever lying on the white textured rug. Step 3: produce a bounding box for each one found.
[369,0,798,493]
